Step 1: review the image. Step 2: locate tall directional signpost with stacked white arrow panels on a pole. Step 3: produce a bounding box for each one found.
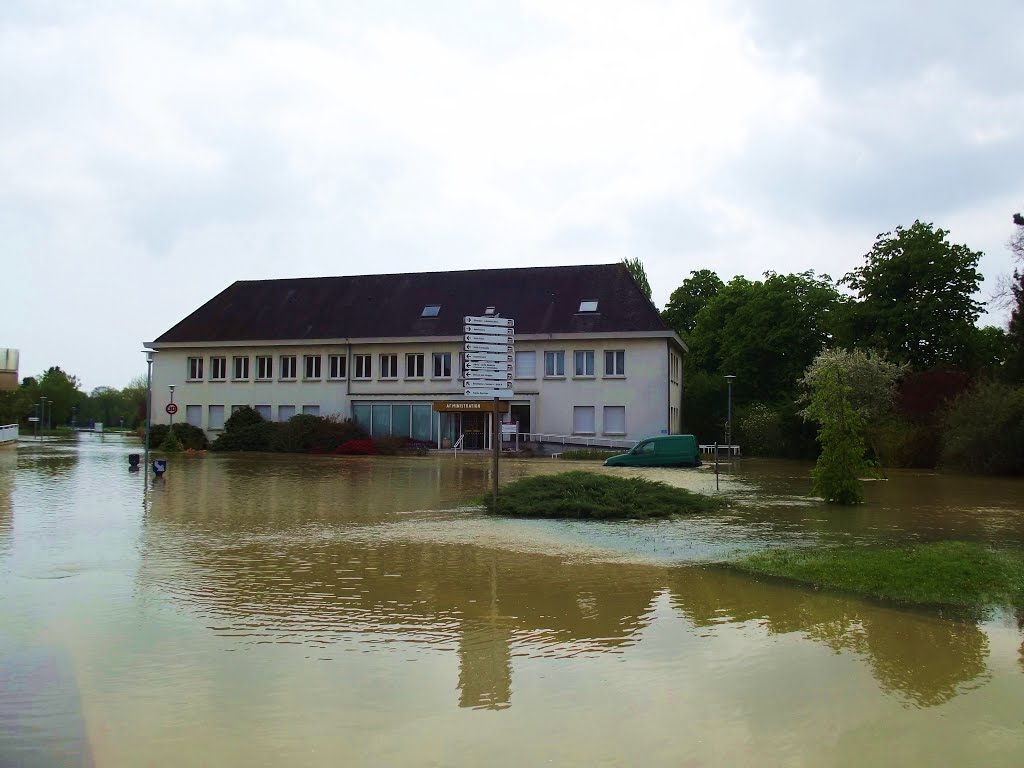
[463,314,515,508]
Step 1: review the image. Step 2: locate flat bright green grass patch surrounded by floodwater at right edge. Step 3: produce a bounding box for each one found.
[729,542,1024,608]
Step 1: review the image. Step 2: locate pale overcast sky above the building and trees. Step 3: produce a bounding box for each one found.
[0,0,1024,390]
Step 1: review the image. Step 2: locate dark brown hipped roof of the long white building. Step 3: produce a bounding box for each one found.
[149,264,667,343]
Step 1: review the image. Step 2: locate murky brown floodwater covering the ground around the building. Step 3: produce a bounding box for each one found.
[0,435,1024,768]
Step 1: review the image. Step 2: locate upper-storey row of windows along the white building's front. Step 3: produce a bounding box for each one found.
[187,349,626,381]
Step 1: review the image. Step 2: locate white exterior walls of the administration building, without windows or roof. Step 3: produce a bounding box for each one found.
[153,338,681,440]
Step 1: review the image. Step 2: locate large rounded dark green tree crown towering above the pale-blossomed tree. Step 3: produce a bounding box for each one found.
[841,221,982,370]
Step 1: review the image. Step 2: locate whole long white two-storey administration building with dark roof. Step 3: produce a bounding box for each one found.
[146,264,686,447]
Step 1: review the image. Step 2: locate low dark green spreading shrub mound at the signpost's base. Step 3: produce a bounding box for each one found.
[484,471,723,520]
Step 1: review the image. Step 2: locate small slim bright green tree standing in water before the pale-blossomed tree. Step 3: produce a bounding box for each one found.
[807,365,869,504]
